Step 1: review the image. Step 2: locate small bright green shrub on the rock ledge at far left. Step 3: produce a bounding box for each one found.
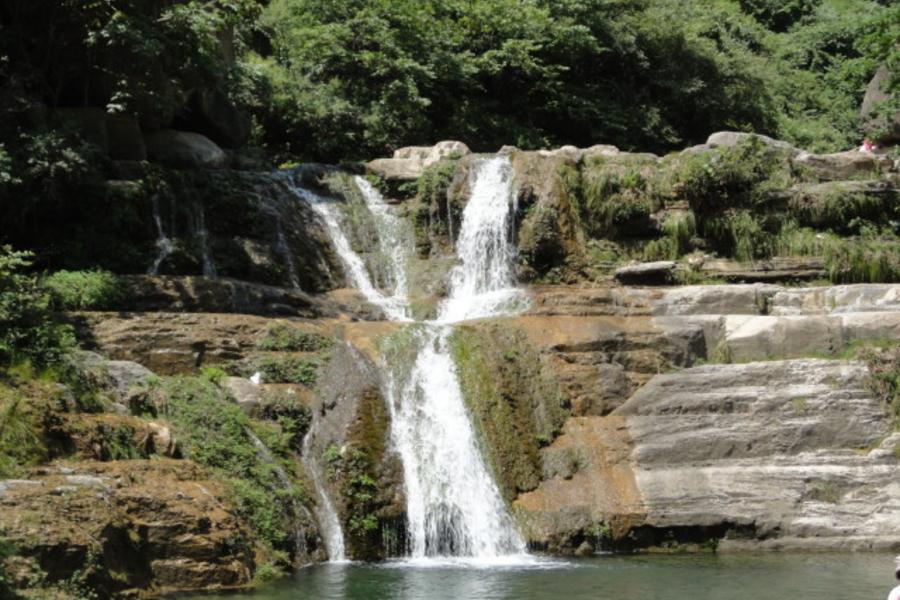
[41,271,124,310]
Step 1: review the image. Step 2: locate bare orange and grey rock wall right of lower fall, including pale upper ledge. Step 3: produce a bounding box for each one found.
[513,284,900,553]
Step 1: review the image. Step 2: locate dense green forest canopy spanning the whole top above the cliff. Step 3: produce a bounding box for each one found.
[0,0,900,170]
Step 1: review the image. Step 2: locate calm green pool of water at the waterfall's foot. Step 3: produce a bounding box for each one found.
[186,554,896,600]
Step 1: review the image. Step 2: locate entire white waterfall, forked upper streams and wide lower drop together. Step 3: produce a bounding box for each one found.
[292,156,526,561]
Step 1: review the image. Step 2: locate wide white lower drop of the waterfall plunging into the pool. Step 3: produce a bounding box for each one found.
[388,325,525,559]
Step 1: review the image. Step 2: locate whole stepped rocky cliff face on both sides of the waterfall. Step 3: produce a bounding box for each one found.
[0,134,900,593]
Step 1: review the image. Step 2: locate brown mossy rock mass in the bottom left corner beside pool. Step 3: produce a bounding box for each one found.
[0,459,254,595]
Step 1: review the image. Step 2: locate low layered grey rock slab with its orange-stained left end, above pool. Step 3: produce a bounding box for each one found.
[514,359,900,551]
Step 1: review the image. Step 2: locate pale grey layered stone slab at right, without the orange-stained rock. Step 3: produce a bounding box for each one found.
[614,360,900,549]
